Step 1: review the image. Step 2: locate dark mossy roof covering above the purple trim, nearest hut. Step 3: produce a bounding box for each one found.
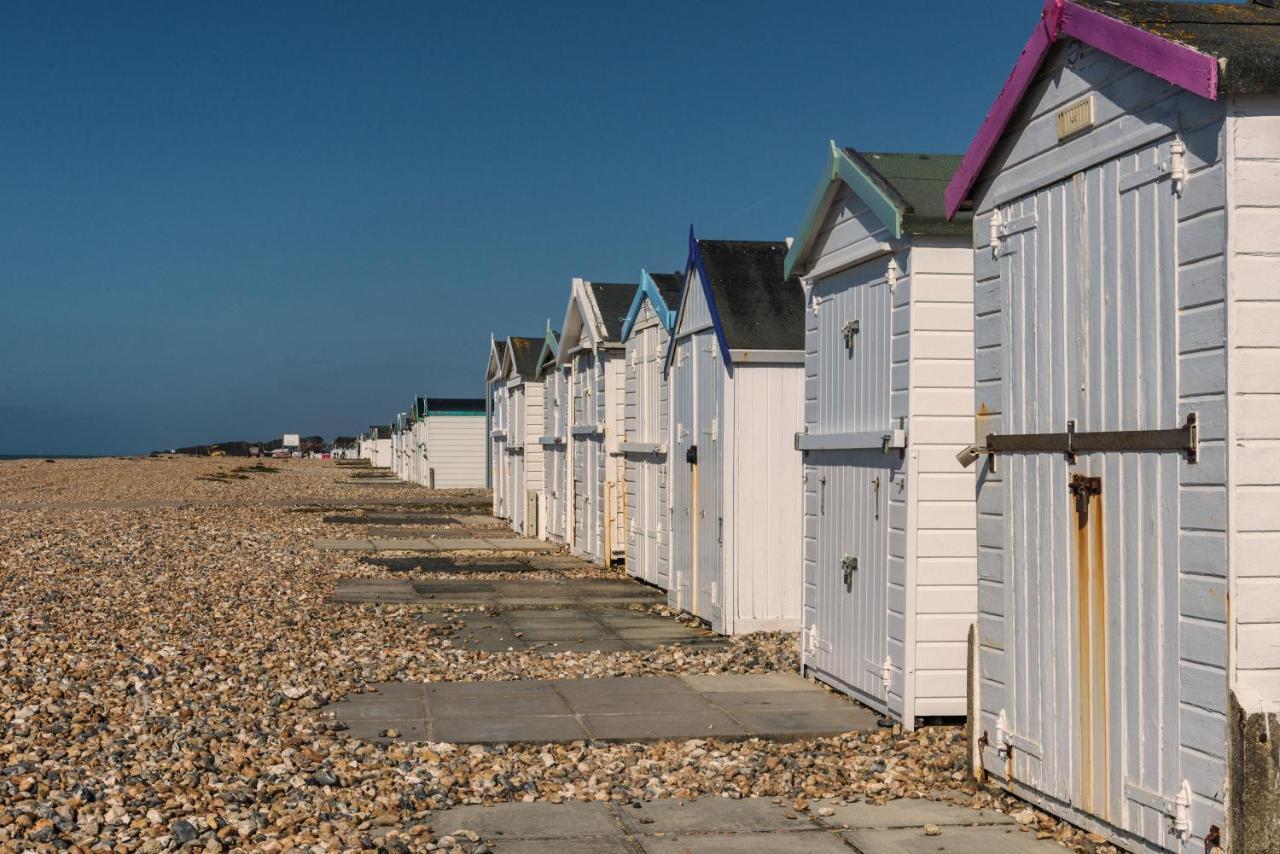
[1076,0,1280,95]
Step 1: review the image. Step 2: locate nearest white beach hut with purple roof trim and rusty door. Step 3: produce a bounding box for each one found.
[946,0,1280,851]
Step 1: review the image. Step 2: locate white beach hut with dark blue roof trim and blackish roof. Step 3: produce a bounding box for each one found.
[666,230,804,634]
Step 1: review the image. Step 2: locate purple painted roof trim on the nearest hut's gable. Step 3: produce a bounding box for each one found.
[946,0,1217,219]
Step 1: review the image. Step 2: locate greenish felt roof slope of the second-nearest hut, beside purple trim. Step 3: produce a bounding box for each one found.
[845,149,973,234]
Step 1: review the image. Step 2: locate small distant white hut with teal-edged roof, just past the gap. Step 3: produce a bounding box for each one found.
[419,397,486,489]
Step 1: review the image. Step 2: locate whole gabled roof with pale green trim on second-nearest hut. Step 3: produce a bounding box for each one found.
[786,141,970,275]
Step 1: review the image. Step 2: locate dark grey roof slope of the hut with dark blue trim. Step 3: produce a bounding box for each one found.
[698,241,804,350]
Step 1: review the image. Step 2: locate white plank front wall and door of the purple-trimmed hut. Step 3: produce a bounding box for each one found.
[967,40,1228,851]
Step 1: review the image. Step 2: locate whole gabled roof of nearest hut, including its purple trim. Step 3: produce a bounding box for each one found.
[946,0,1280,216]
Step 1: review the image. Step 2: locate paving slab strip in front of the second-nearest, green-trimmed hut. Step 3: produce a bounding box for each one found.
[328,673,876,744]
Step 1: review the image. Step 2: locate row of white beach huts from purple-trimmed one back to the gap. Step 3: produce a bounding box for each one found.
[388,0,1280,853]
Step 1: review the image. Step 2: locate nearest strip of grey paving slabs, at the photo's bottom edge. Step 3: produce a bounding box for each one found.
[394,798,1064,854]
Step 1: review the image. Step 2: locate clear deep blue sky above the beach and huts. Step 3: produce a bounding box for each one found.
[0,0,1041,453]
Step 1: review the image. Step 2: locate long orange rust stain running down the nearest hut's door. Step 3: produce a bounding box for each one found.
[1070,475,1111,818]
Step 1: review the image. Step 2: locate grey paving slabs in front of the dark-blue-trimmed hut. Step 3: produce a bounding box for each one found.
[412,608,728,653]
